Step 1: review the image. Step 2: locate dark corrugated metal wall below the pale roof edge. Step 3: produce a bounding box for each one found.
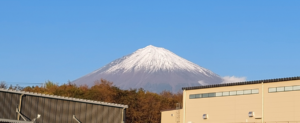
[0,91,125,123]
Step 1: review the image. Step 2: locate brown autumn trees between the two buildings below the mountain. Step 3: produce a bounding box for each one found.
[0,79,182,123]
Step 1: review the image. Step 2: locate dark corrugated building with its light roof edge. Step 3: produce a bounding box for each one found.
[0,89,128,123]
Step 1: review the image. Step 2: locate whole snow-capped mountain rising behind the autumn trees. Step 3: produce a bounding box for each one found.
[73,45,222,92]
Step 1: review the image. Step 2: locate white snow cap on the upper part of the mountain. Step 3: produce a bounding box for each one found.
[98,45,212,75]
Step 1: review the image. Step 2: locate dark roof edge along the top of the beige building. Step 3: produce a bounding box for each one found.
[182,76,300,90]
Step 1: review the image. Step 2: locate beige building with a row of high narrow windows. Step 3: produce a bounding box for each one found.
[161,77,300,123]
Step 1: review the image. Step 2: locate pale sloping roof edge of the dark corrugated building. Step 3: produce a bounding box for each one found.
[0,88,128,107]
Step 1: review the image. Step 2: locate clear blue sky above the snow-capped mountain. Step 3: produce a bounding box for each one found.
[0,0,300,84]
